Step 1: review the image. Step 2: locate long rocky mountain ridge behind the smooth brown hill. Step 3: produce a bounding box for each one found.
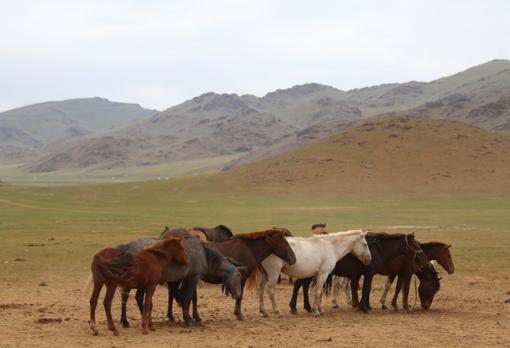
[9,60,510,172]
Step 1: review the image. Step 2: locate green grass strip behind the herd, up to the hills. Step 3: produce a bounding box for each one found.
[0,176,510,283]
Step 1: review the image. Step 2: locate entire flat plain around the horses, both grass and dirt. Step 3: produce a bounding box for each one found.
[0,175,510,347]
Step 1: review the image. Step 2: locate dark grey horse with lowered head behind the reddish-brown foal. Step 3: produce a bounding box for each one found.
[121,228,247,327]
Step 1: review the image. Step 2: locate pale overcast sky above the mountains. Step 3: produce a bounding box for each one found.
[0,0,510,111]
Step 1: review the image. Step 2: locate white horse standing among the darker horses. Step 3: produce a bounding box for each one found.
[257,230,372,317]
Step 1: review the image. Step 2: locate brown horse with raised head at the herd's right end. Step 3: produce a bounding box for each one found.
[380,242,455,311]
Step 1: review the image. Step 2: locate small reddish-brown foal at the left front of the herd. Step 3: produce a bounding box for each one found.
[90,237,190,336]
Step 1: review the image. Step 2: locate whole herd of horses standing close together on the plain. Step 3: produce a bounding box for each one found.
[90,224,455,335]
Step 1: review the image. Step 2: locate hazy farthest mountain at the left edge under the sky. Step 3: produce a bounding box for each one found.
[0,97,156,160]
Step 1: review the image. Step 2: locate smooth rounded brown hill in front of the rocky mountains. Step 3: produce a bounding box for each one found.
[217,117,510,192]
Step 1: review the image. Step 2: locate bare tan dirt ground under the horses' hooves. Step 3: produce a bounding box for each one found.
[0,274,510,347]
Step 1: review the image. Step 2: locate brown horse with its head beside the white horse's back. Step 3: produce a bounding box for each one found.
[203,227,296,320]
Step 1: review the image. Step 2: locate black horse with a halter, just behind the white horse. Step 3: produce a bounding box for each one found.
[289,232,429,314]
